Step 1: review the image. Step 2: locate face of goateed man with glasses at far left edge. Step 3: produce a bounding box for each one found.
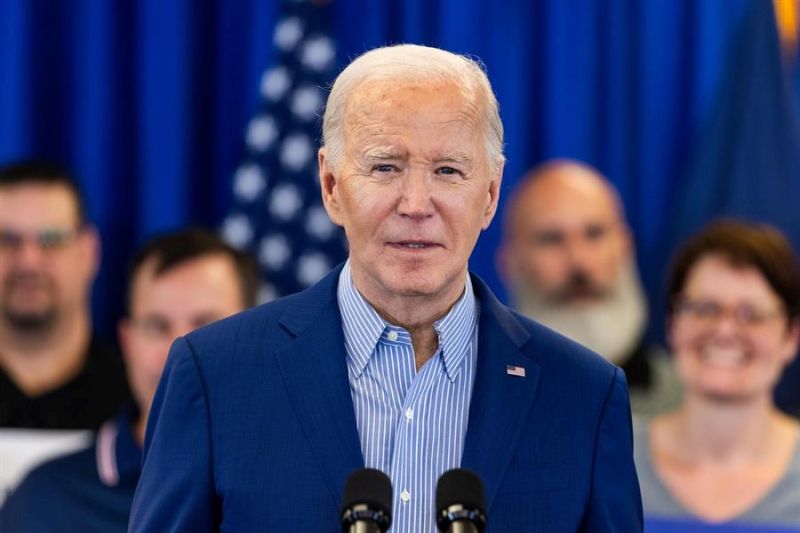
[0,183,99,330]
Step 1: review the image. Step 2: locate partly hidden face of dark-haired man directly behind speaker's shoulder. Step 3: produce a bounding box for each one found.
[119,254,244,413]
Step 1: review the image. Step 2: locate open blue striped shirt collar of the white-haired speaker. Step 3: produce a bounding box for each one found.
[337,260,478,381]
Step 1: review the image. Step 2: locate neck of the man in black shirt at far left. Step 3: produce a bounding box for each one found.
[0,311,90,397]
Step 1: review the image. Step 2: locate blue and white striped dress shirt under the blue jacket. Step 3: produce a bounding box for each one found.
[338,262,478,533]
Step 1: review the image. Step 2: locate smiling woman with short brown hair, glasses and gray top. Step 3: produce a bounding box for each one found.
[635,220,800,533]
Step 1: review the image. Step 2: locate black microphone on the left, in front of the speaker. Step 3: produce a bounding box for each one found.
[340,468,392,533]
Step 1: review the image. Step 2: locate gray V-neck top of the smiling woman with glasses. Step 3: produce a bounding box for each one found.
[633,424,800,526]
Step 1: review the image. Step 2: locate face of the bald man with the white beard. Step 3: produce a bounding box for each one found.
[506,170,631,306]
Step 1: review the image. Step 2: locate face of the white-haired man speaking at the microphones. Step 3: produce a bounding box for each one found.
[320,83,502,306]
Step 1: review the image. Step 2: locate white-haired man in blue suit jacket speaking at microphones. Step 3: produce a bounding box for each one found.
[131,45,642,533]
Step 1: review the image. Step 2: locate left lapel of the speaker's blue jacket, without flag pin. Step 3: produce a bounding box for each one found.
[276,269,364,504]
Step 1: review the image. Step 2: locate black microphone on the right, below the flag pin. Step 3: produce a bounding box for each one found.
[436,468,486,533]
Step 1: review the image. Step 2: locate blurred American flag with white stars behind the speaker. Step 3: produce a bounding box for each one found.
[222,0,346,301]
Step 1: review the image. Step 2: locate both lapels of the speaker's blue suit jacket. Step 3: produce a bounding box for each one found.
[276,268,540,508]
